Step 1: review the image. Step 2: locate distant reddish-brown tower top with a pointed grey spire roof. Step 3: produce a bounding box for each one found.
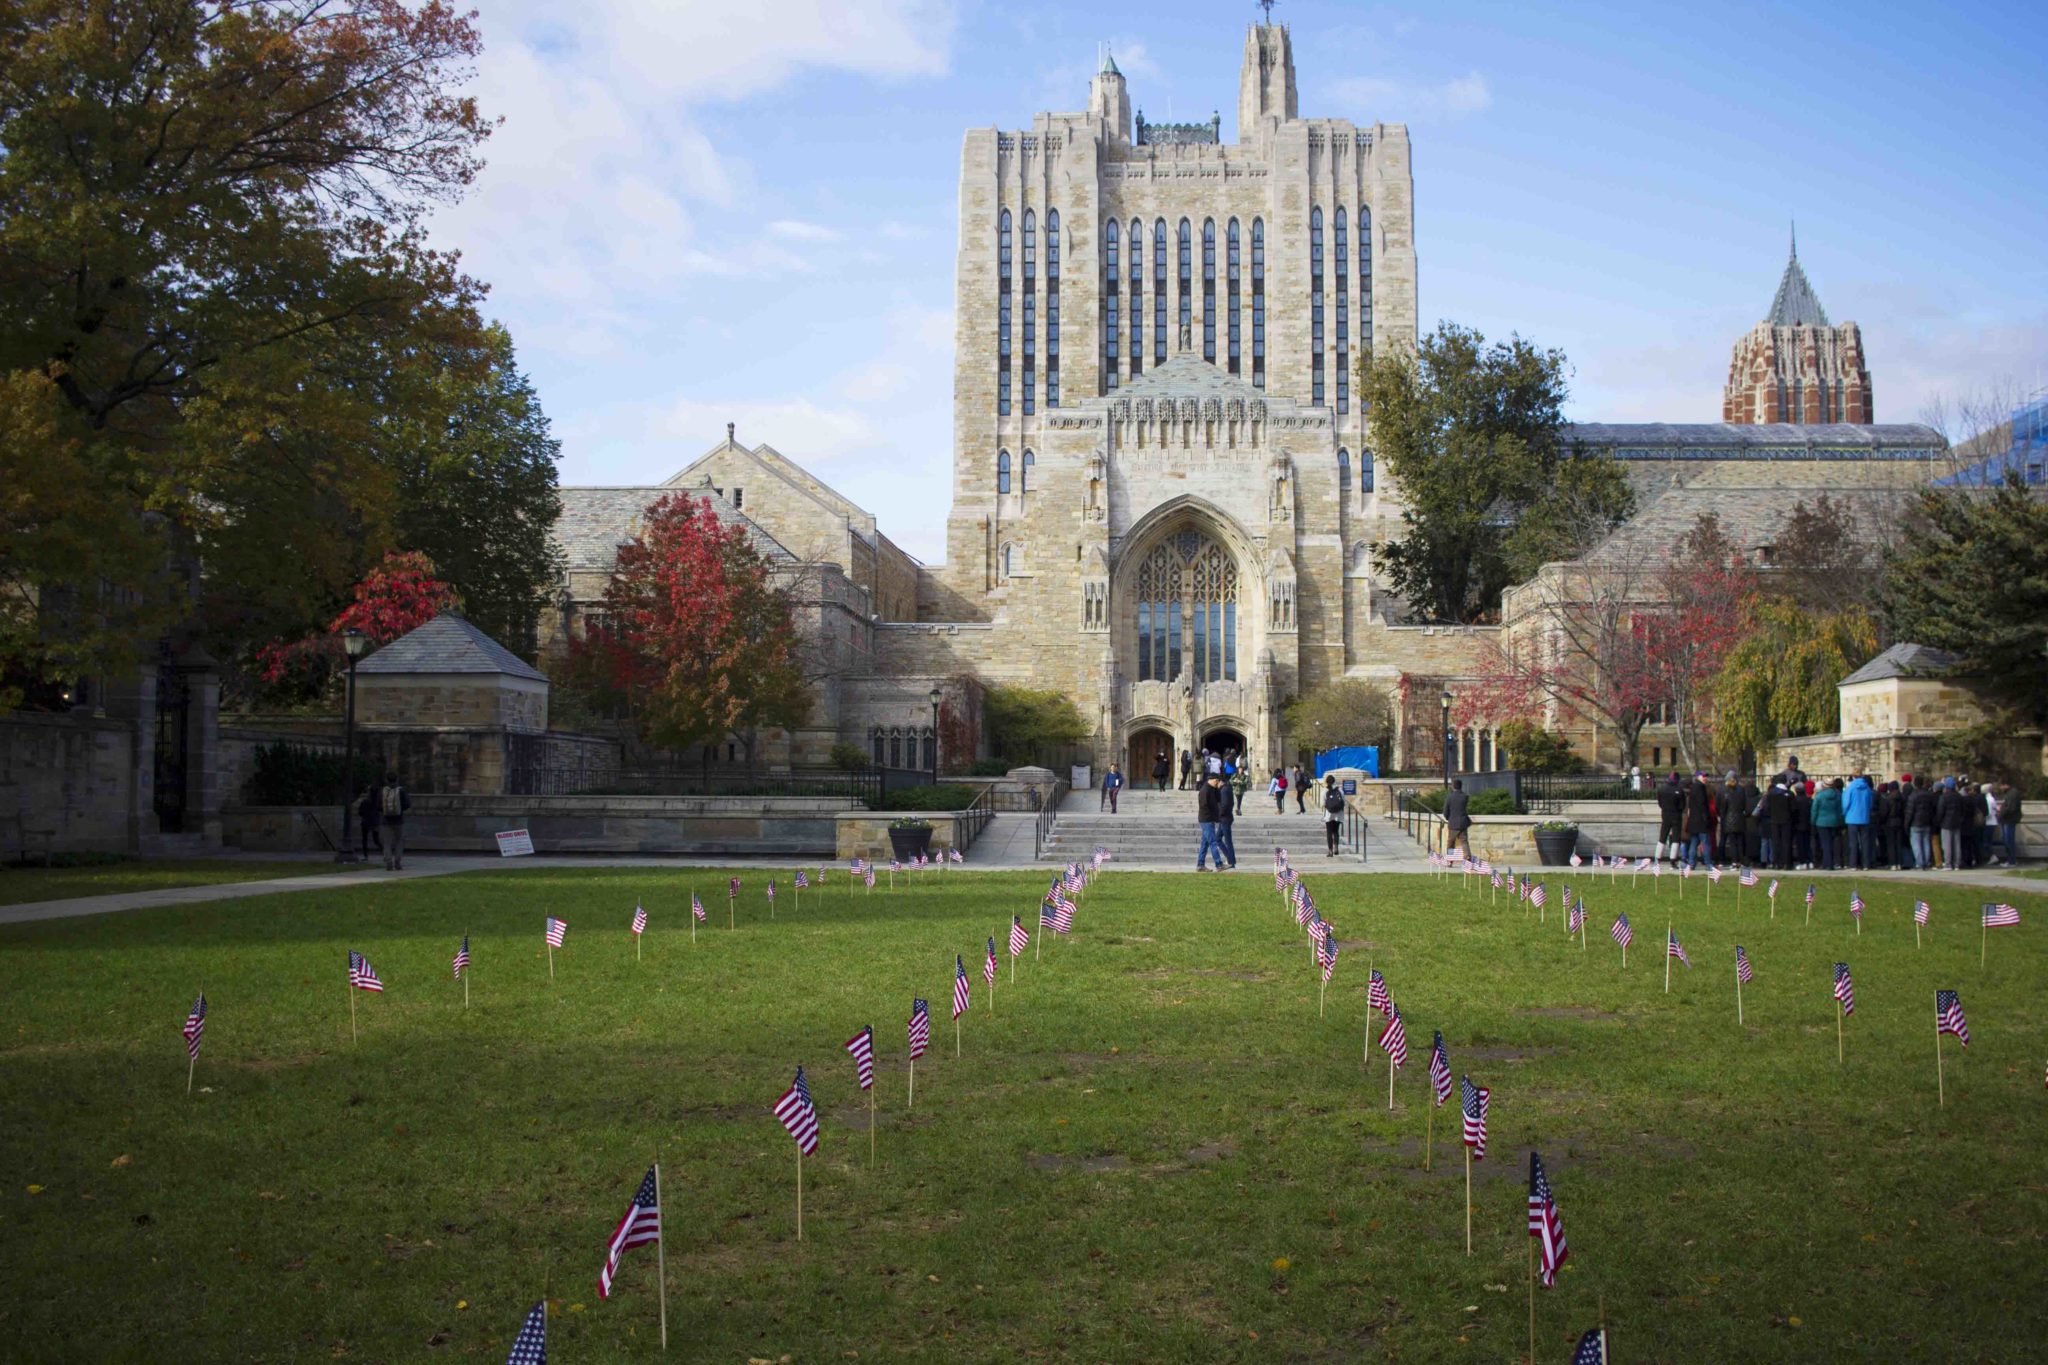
[1720,237,1878,424]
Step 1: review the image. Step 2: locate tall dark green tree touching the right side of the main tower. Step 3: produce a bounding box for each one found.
[1360,323,1634,622]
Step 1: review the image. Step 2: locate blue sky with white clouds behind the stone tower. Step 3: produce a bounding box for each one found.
[436,0,2048,561]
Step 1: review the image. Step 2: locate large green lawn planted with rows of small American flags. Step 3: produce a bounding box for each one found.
[0,860,2048,1363]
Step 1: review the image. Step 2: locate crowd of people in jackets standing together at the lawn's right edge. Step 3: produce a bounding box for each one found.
[1657,757,2023,872]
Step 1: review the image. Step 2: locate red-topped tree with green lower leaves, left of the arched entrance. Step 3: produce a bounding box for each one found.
[571,493,809,761]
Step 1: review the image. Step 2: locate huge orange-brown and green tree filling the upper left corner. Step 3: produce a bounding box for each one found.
[0,0,487,699]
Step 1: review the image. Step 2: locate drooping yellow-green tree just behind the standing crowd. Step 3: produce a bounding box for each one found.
[1712,593,1878,753]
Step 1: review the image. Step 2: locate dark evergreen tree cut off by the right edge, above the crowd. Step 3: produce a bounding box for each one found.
[1878,475,2048,724]
